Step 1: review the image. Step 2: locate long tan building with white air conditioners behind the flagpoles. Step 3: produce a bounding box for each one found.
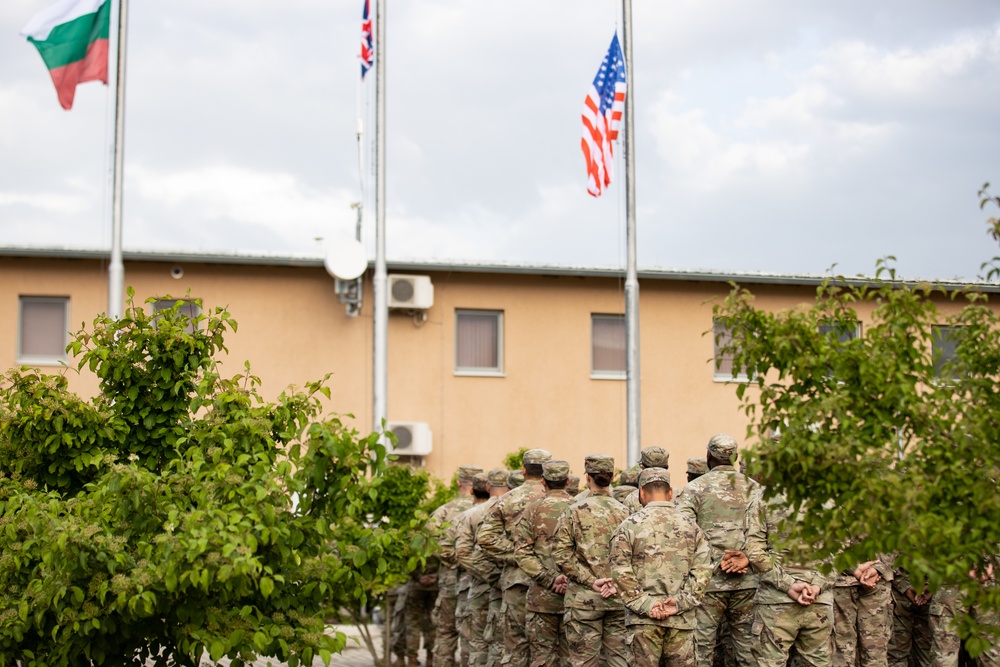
[0,248,988,485]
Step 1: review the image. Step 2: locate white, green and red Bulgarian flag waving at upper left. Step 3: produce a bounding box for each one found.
[21,0,111,109]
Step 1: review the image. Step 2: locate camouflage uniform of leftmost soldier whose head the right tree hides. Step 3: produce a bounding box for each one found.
[743,489,834,667]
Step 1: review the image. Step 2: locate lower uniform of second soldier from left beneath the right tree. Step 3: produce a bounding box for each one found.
[833,559,893,667]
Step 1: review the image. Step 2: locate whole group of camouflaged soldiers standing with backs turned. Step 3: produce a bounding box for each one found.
[386,435,1000,667]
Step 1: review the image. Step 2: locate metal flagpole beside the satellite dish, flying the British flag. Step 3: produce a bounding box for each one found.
[372,0,389,438]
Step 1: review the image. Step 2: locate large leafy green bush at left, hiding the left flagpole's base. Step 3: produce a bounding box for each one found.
[0,290,427,666]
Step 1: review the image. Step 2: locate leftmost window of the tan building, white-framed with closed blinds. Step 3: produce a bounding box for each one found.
[17,296,69,366]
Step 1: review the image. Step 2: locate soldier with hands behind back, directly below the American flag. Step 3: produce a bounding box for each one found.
[552,454,629,667]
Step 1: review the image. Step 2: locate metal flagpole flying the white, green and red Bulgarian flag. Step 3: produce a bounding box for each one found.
[108,0,128,319]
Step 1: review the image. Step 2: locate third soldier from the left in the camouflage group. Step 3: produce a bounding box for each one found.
[455,468,507,665]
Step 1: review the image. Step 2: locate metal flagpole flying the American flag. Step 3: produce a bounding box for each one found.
[622,0,641,466]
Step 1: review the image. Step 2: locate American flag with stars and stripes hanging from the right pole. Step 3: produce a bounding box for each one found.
[580,33,625,197]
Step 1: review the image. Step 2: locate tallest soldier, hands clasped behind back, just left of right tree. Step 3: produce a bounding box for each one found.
[674,434,758,667]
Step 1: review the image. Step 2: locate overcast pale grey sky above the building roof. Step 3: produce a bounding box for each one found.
[0,0,1000,278]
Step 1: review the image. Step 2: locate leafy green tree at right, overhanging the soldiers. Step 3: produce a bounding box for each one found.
[714,190,1000,655]
